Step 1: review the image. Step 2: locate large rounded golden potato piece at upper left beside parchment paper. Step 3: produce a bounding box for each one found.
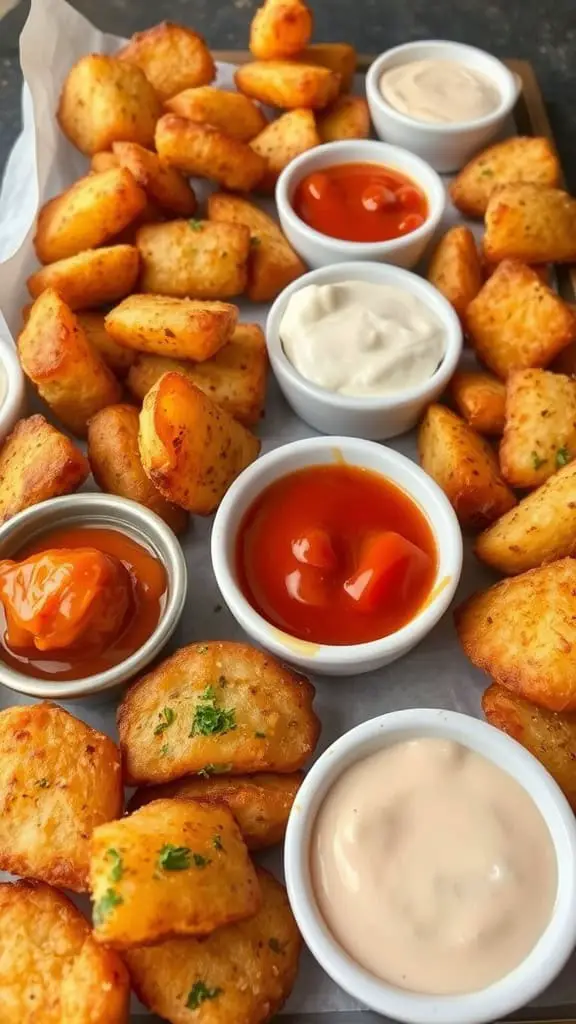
[56,53,161,157]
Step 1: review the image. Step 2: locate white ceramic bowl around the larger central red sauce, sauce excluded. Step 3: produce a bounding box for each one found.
[211,437,462,676]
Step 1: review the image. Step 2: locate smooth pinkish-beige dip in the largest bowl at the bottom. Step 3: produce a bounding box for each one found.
[311,738,558,995]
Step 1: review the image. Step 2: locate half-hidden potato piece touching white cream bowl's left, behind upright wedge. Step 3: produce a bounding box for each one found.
[128,324,268,427]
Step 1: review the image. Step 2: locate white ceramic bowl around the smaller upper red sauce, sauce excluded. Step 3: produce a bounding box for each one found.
[276,139,446,268]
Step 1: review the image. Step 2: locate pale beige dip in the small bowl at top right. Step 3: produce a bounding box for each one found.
[380,59,501,124]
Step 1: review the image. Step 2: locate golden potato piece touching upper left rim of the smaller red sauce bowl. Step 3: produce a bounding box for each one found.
[250,110,321,193]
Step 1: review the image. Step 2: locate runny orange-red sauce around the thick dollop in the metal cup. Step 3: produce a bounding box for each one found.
[0,526,168,680]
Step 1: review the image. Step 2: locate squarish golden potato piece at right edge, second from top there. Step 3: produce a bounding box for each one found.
[483,182,576,263]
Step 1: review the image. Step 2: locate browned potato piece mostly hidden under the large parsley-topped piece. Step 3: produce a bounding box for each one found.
[129,772,303,850]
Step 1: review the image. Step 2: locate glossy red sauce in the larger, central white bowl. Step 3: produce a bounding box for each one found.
[236,465,438,644]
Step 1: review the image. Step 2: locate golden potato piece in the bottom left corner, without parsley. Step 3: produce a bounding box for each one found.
[0,882,130,1024]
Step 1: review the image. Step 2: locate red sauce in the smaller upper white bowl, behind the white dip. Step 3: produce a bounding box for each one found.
[292,164,428,242]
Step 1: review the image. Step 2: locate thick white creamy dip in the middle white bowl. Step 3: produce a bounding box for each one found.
[280,281,446,398]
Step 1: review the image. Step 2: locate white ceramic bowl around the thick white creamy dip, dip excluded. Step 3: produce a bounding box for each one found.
[266,263,462,440]
